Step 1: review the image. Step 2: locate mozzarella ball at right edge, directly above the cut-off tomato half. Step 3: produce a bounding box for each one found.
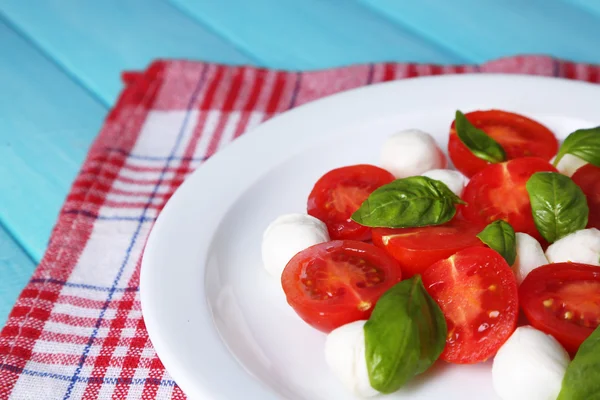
[546,228,600,265]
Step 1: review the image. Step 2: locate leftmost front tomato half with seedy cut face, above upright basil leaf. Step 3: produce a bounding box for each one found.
[281,240,402,332]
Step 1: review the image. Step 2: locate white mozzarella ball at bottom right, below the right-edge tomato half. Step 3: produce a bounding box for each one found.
[492,326,571,400]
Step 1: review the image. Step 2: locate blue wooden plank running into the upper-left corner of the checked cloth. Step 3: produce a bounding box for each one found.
[0,0,254,104]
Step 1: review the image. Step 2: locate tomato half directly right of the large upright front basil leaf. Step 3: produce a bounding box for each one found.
[422,247,519,364]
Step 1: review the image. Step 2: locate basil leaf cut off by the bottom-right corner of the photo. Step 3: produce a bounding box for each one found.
[557,326,600,400]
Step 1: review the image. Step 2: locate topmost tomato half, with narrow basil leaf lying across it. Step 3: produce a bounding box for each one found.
[448,110,558,177]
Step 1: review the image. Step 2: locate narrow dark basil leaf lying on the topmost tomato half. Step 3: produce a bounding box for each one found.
[454,111,506,163]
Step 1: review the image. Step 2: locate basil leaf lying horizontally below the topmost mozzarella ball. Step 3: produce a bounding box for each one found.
[352,176,464,228]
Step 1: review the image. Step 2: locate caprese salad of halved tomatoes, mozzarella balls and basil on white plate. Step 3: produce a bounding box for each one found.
[262,110,600,400]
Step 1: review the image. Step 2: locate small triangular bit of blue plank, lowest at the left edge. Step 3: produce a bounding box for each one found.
[0,225,36,326]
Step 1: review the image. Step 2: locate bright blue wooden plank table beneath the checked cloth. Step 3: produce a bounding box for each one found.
[0,0,600,325]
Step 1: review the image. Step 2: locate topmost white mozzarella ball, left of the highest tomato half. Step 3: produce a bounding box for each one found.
[381,129,446,178]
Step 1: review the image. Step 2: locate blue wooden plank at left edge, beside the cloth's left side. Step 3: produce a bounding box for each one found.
[0,20,106,260]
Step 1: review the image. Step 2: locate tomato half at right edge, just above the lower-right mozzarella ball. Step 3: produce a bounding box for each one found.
[519,262,600,354]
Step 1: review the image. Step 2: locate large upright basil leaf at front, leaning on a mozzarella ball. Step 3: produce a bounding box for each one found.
[364,275,448,393]
